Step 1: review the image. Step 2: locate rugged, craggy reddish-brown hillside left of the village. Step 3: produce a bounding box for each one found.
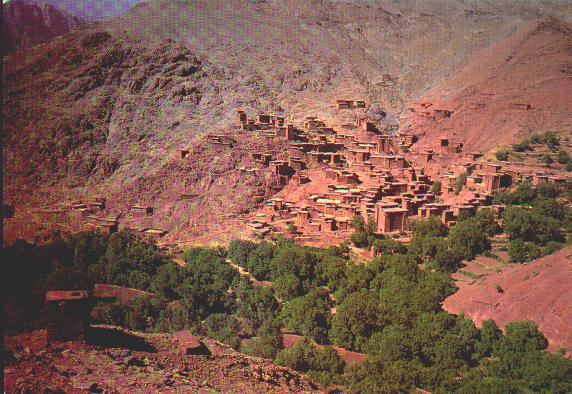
[4,28,290,245]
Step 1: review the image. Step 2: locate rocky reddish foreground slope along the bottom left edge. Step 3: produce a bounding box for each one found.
[4,331,320,393]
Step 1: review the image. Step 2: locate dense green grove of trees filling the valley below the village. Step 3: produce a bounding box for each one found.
[4,185,572,393]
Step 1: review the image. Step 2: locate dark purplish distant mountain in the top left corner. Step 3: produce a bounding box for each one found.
[2,0,84,54]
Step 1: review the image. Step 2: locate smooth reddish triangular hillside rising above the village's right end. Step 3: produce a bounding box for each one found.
[409,18,572,152]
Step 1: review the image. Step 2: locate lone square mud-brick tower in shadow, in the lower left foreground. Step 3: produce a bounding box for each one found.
[45,291,90,343]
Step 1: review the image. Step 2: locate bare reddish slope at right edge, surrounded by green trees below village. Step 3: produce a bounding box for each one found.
[443,247,572,351]
